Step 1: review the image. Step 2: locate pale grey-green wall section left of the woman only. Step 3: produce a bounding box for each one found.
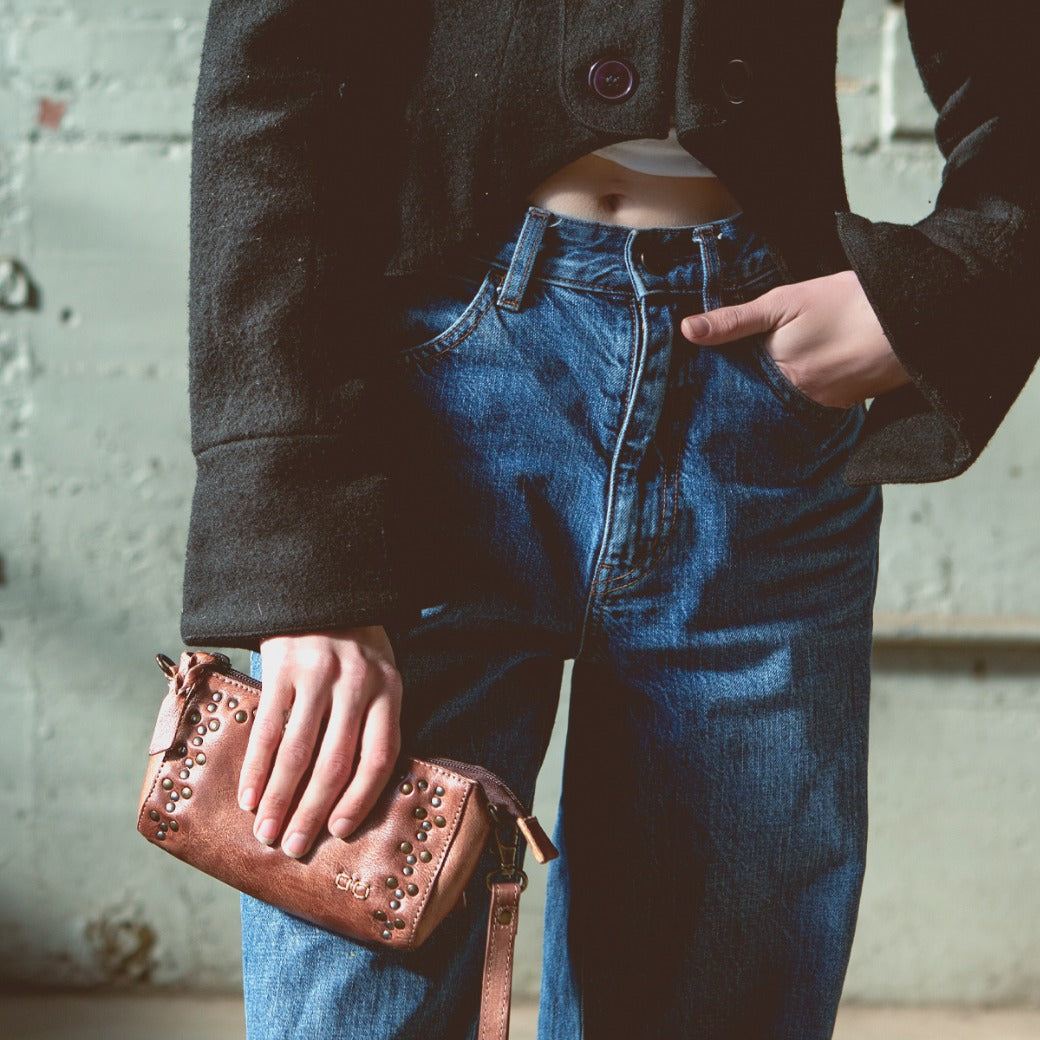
[0,0,215,984]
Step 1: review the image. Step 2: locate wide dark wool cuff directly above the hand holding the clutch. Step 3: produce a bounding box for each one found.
[181,436,397,649]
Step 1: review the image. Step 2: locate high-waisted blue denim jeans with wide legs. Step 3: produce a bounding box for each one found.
[243,208,881,1040]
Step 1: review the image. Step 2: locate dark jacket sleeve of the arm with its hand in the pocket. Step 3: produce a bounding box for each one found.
[838,0,1040,484]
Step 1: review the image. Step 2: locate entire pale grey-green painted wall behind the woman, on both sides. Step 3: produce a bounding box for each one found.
[0,0,1040,1003]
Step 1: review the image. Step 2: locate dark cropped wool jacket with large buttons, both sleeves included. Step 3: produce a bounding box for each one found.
[183,0,1040,646]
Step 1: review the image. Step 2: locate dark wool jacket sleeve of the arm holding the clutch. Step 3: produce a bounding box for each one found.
[182,0,405,647]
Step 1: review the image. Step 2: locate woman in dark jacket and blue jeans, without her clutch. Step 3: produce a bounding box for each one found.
[183,0,1037,1040]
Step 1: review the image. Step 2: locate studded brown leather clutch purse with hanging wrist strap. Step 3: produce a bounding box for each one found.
[137,652,556,1038]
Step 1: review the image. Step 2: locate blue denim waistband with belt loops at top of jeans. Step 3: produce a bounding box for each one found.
[478,206,777,308]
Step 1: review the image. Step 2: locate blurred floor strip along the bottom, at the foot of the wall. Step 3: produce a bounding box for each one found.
[6,994,1040,1040]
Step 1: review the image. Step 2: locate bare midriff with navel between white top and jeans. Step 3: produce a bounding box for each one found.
[527,155,740,228]
